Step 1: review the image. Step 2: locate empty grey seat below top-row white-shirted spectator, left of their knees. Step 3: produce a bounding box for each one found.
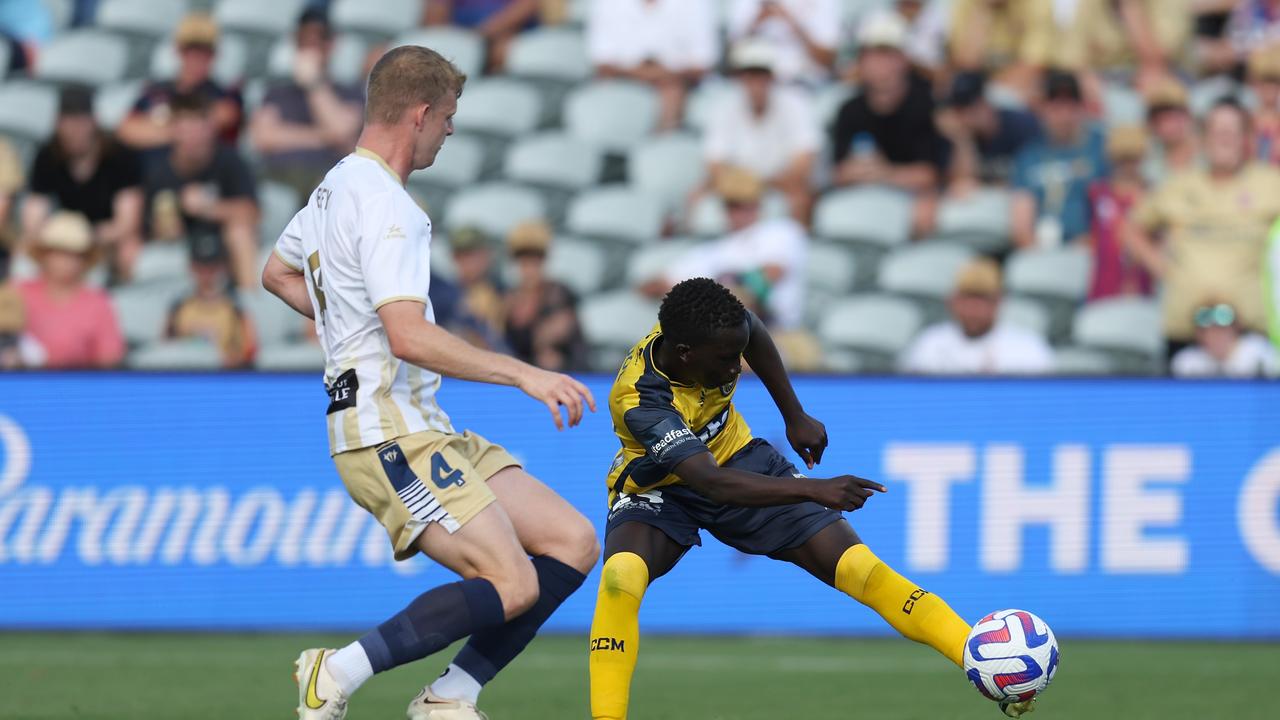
[564,81,658,152]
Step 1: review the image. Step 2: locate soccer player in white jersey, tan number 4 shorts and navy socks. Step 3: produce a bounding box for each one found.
[262,46,599,720]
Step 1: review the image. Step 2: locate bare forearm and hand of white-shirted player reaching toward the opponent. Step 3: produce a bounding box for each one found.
[378,300,595,429]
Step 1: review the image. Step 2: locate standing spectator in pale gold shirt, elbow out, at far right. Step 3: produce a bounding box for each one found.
[1125,100,1280,354]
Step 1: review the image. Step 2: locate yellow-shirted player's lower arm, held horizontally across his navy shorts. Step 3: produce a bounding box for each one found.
[676,452,884,510]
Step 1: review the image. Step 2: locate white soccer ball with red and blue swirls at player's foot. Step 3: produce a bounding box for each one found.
[964,610,1059,702]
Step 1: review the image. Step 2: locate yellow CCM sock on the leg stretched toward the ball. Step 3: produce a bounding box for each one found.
[836,544,969,665]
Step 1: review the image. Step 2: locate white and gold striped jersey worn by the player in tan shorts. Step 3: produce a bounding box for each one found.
[275,149,453,455]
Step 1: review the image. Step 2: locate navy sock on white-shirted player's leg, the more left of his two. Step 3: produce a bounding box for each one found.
[360,578,506,673]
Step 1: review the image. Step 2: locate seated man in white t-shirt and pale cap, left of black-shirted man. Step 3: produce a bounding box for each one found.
[703,40,822,223]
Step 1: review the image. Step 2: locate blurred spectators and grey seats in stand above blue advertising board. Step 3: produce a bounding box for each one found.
[0,0,1280,378]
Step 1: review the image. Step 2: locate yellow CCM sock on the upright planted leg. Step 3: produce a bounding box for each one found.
[588,552,649,720]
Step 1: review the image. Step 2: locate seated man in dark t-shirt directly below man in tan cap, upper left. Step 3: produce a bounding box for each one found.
[143,95,259,291]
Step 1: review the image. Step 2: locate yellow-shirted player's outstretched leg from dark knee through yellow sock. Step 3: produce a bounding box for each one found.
[771,520,969,665]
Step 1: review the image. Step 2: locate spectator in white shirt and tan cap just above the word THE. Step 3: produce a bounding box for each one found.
[900,259,1053,375]
